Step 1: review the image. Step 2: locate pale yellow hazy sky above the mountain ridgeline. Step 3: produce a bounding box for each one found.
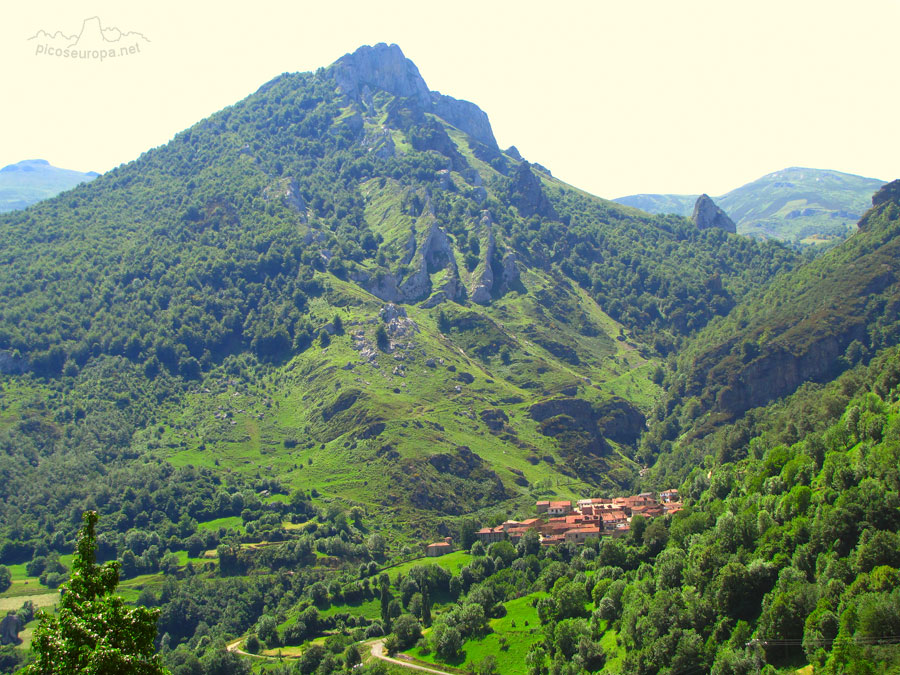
[0,0,900,198]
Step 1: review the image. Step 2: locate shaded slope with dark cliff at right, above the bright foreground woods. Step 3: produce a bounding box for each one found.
[652,181,900,438]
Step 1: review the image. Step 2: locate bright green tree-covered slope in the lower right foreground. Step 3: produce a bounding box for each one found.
[396,348,900,675]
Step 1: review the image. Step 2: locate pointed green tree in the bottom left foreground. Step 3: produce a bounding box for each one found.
[23,511,169,675]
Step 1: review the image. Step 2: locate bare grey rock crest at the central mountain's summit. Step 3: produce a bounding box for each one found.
[331,43,498,149]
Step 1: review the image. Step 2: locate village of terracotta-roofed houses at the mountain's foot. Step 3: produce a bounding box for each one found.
[425,489,682,557]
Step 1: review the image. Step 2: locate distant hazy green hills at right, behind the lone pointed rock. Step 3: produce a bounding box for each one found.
[615,167,884,245]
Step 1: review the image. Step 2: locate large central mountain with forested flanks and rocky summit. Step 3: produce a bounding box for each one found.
[0,45,794,552]
